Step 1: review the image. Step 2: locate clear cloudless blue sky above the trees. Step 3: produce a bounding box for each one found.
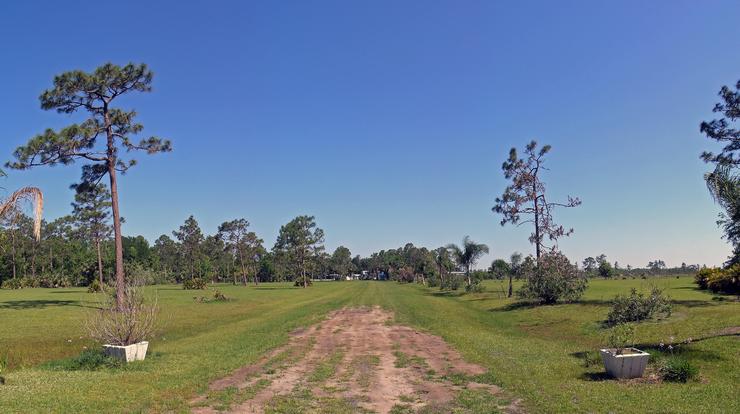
[0,0,740,266]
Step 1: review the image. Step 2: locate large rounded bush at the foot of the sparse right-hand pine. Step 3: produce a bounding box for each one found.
[517,252,588,304]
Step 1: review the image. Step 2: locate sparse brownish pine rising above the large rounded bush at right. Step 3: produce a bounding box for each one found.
[492,141,581,259]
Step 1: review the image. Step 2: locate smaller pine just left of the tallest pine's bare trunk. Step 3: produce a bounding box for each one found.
[72,184,113,287]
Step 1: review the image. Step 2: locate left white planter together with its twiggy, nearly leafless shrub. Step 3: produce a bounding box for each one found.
[86,281,158,362]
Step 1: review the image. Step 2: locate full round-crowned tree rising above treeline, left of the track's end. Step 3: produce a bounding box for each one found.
[273,216,324,288]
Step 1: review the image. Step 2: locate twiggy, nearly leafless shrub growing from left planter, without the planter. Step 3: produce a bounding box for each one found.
[85,279,158,345]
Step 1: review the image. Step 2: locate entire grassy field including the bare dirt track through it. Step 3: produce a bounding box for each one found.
[0,276,740,414]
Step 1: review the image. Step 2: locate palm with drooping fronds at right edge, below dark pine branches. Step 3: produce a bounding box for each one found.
[704,164,740,265]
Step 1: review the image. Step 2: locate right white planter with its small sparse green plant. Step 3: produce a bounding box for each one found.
[600,323,650,378]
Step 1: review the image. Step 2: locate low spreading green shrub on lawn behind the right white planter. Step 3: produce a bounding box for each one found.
[606,286,671,325]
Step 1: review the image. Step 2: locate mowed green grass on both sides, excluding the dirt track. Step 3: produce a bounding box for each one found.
[0,277,740,413]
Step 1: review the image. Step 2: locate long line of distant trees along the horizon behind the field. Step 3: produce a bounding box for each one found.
[0,207,706,287]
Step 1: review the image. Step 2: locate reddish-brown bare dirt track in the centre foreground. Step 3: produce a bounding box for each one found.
[191,307,522,413]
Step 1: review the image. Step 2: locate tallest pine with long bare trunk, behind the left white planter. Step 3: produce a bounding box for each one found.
[6,63,171,309]
